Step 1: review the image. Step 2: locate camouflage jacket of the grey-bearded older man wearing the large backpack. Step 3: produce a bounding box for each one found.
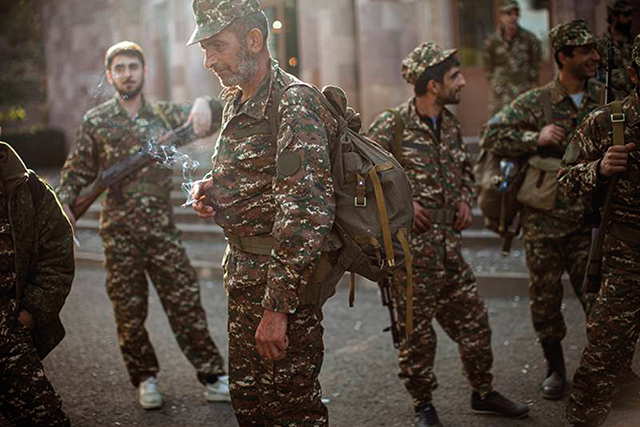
[211,61,337,313]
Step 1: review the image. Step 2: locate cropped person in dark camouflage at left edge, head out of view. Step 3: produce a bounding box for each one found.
[0,142,75,427]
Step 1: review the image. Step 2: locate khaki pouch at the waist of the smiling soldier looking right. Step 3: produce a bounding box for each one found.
[517,156,562,211]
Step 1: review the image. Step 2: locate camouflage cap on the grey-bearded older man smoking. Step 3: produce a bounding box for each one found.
[187,0,262,46]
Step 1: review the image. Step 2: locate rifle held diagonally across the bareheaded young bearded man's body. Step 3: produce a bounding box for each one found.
[71,123,196,220]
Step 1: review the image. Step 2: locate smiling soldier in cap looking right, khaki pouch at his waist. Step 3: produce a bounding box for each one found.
[480,20,603,399]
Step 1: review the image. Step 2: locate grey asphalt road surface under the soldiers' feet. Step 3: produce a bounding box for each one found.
[18,270,640,427]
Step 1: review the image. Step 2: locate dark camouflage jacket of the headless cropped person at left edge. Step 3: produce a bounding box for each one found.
[0,142,75,357]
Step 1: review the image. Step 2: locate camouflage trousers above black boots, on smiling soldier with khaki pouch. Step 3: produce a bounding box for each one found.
[524,228,591,343]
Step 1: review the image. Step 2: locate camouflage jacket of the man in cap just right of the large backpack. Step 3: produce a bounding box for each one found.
[367,99,475,270]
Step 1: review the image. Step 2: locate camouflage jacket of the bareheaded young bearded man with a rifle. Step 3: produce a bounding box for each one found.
[57,97,222,232]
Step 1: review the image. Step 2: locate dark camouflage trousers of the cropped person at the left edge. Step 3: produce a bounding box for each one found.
[0,321,71,427]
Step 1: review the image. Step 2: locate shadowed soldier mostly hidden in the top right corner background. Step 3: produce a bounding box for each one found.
[598,0,633,99]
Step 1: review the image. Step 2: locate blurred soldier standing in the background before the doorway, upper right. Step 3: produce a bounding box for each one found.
[482,0,542,115]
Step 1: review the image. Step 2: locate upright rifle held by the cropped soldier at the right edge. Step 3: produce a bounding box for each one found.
[582,40,618,293]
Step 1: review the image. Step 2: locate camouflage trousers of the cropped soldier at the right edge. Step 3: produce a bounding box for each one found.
[567,235,640,426]
